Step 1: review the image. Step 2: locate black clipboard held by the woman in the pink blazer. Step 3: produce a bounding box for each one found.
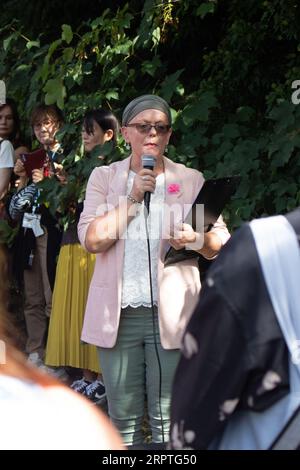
[164,176,241,271]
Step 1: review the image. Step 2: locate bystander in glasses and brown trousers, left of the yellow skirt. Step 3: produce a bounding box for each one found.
[14,104,64,372]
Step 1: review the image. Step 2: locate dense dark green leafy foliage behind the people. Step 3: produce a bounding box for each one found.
[0,0,300,239]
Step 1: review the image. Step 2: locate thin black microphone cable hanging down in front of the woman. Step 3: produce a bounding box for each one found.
[144,206,165,444]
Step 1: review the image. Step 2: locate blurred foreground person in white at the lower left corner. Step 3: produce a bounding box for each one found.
[0,246,124,450]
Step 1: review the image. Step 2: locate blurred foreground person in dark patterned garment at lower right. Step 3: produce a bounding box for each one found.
[170,209,300,450]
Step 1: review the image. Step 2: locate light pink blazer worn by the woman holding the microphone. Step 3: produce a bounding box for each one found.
[78,158,229,349]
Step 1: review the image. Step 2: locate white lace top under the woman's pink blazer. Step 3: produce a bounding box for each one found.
[122,170,165,308]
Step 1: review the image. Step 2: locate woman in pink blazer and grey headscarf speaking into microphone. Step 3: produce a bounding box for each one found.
[78,95,229,445]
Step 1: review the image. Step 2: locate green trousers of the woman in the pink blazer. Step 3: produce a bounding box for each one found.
[98,307,180,445]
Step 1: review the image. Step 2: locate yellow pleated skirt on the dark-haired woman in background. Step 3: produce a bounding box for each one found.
[45,243,100,373]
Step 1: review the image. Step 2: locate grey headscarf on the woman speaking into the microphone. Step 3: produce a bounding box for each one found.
[122,95,172,126]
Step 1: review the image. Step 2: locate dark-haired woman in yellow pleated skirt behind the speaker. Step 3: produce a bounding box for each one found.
[45,108,118,404]
